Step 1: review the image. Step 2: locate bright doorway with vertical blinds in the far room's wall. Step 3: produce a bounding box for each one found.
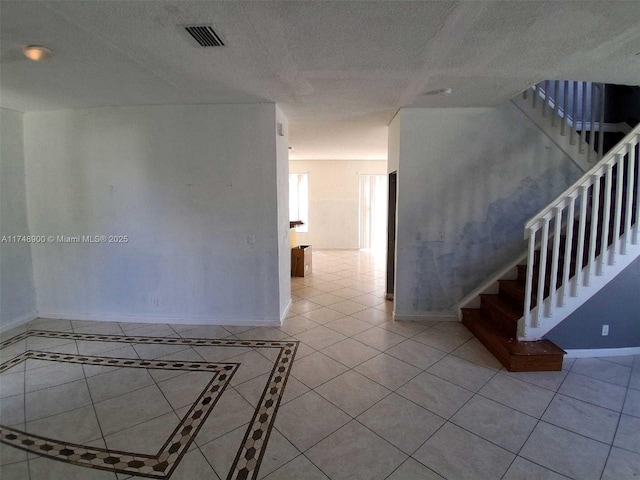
[359,175,388,252]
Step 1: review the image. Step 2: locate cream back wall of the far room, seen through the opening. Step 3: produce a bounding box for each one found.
[289,160,387,249]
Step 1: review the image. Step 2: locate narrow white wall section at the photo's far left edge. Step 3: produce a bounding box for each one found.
[0,108,36,330]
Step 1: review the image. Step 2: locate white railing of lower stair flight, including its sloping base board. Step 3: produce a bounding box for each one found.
[519,124,640,340]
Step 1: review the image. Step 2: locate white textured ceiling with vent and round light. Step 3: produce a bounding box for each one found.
[0,0,640,159]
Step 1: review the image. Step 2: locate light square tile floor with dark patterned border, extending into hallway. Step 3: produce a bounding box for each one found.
[0,251,640,480]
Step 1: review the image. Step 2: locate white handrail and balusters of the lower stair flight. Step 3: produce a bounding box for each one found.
[520,124,640,338]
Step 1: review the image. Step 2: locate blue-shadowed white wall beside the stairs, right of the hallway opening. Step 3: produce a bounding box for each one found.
[390,103,580,319]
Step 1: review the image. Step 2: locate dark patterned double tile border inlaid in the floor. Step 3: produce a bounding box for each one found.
[0,330,299,480]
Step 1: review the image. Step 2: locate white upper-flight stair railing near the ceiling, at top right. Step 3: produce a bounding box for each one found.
[522,80,605,163]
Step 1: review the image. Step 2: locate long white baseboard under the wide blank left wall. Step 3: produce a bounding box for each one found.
[38,312,280,327]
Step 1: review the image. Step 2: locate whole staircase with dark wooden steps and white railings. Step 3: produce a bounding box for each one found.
[461,82,640,371]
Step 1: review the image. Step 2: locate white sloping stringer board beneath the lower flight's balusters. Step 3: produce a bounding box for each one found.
[518,238,640,341]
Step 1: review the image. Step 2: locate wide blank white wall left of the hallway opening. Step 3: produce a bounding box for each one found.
[24,104,281,324]
